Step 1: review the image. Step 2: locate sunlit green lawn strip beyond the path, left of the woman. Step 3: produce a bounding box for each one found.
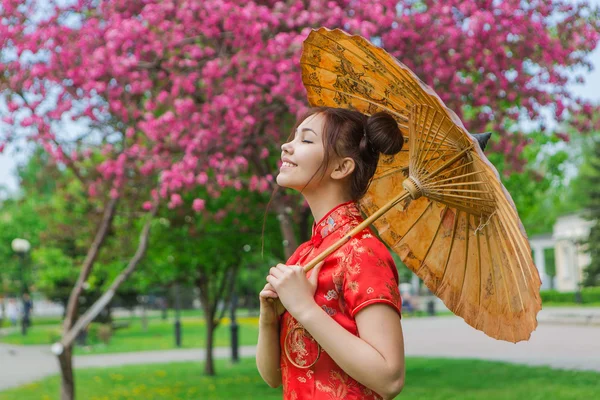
[0,317,258,354]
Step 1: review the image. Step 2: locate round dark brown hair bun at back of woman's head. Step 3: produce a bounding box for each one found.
[366,111,404,155]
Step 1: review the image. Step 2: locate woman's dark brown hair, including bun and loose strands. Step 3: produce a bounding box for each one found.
[289,107,404,201]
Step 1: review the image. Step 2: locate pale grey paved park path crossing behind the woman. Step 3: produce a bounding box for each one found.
[0,308,600,391]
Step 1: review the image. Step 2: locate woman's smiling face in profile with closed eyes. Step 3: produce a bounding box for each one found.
[277,114,327,192]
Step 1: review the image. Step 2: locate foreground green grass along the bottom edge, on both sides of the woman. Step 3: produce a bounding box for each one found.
[0,358,600,400]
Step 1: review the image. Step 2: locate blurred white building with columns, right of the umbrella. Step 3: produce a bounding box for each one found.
[529,213,593,292]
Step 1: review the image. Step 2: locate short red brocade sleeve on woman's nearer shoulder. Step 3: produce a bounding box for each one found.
[344,238,402,318]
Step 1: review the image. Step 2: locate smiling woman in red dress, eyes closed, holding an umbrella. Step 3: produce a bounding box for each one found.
[256,108,404,400]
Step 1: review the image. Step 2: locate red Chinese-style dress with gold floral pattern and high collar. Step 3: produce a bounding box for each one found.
[280,202,402,400]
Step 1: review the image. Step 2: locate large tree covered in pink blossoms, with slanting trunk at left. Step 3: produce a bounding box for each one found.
[0,0,600,399]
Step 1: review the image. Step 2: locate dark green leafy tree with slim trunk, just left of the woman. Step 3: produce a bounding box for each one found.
[141,189,285,375]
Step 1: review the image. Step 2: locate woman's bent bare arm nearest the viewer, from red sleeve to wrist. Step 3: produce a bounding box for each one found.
[295,303,405,399]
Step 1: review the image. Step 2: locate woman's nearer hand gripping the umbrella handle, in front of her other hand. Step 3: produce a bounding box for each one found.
[268,261,324,319]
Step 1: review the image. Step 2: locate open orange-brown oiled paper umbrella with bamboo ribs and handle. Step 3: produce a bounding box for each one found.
[301,28,541,343]
